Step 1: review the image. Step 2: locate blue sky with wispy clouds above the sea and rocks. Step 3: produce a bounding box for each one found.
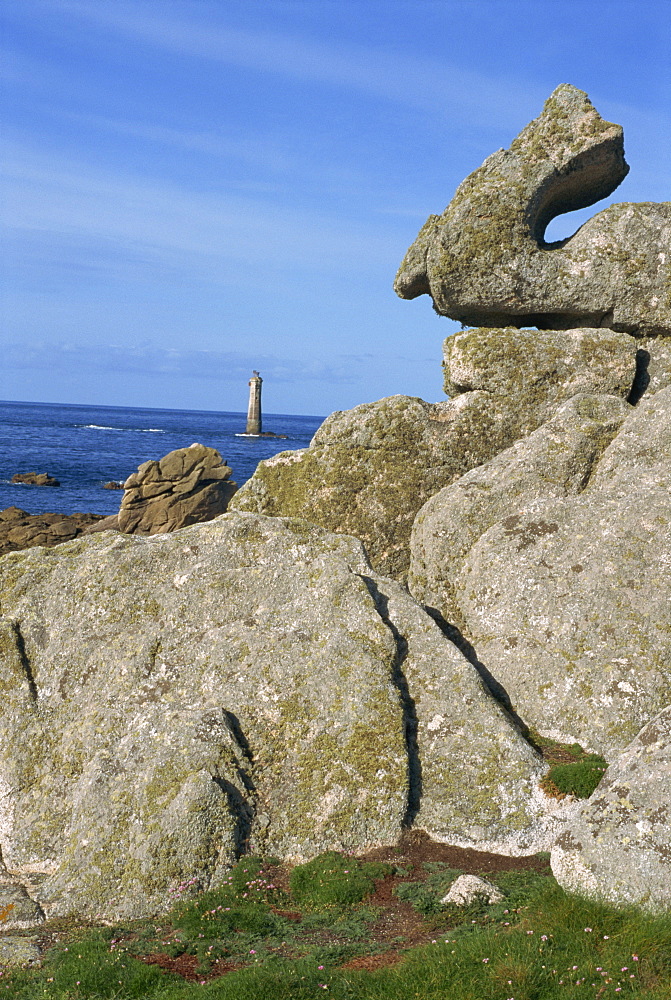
[0,0,671,414]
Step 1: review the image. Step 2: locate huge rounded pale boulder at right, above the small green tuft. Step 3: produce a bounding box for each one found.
[411,389,671,758]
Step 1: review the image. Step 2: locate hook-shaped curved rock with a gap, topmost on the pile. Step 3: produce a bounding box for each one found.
[395,84,671,335]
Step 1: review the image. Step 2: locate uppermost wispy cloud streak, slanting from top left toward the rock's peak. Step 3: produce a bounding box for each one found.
[47,0,547,128]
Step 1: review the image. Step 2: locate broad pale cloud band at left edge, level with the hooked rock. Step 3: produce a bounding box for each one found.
[4,144,397,278]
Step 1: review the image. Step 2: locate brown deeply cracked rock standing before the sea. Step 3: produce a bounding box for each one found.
[117,444,238,535]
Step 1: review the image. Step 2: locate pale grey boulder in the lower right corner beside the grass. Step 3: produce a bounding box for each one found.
[551,708,671,911]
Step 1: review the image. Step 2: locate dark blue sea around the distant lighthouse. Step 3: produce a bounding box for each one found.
[0,402,324,514]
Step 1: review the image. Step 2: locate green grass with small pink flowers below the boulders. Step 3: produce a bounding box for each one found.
[0,855,671,1000]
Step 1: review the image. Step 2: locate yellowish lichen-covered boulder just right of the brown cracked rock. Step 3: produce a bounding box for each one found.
[230,392,519,580]
